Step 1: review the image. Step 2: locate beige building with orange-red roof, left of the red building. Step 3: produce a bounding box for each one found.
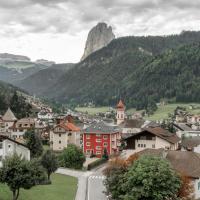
[50,122,81,151]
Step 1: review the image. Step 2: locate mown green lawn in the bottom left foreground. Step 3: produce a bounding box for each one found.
[0,174,77,200]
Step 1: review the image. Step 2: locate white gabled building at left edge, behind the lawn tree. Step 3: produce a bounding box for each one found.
[0,135,30,167]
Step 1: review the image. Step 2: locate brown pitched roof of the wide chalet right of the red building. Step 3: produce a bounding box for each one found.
[125,127,181,144]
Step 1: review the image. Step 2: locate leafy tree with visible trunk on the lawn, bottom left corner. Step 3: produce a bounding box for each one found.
[0,154,46,200]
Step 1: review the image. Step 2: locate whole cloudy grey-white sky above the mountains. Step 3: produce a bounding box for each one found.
[0,0,200,63]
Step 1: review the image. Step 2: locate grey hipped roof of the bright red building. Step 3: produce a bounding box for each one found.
[84,121,120,134]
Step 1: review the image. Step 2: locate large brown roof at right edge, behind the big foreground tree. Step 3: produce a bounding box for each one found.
[137,149,200,178]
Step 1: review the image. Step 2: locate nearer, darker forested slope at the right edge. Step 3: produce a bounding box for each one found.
[122,43,200,108]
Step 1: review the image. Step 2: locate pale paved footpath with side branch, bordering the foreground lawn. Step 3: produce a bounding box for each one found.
[56,168,93,200]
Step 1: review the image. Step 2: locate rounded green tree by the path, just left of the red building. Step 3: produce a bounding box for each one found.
[59,144,85,169]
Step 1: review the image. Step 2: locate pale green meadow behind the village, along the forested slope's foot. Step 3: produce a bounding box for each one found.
[76,103,200,120]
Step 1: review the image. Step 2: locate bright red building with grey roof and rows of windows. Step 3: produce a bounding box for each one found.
[83,122,121,157]
